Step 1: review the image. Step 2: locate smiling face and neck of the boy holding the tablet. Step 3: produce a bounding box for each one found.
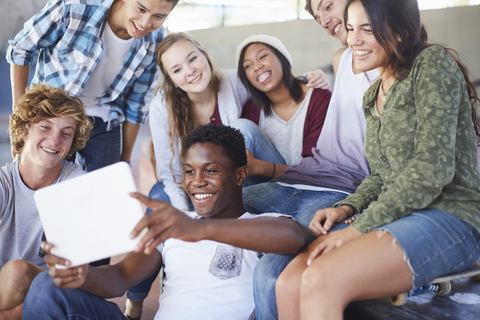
[184,142,246,219]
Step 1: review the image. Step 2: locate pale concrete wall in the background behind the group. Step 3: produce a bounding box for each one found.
[0,0,480,79]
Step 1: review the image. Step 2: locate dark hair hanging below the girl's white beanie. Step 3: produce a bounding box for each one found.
[237,42,307,116]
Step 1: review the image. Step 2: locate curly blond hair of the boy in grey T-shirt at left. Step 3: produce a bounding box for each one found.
[8,84,93,156]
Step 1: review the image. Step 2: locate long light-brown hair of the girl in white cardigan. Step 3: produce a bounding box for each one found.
[150,32,222,177]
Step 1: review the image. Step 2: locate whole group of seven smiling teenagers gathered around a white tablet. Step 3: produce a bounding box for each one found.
[0,0,480,320]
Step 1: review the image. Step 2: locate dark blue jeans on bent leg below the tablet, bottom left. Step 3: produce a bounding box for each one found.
[22,272,125,320]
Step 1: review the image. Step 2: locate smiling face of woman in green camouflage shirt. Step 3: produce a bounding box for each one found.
[347,1,388,74]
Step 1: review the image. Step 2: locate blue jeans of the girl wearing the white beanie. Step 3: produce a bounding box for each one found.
[229,119,287,187]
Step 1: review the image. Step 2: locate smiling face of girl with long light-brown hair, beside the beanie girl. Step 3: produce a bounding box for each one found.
[160,40,212,94]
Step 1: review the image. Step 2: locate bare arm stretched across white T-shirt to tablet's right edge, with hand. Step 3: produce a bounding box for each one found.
[131,193,305,254]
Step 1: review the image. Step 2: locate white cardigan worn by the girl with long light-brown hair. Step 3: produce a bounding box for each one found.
[150,70,250,210]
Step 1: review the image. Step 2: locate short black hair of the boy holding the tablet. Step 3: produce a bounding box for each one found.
[183,123,247,168]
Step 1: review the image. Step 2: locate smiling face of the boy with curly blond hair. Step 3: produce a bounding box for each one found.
[22,117,77,170]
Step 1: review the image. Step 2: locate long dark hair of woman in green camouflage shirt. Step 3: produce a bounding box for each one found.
[344,0,480,141]
